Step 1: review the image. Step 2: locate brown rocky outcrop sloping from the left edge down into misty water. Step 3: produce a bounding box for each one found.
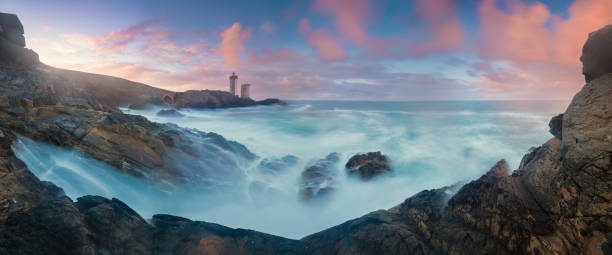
[0,69,255,188]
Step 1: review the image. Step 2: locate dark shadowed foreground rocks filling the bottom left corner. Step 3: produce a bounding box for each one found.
[0,132,306,255]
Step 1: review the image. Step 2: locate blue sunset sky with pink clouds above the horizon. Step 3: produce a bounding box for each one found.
[0,0,612,101]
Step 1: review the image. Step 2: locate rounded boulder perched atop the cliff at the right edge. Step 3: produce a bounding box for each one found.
[580,25,612,82]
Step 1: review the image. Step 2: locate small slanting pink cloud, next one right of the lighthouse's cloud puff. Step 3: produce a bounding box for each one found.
[299,19,347,61]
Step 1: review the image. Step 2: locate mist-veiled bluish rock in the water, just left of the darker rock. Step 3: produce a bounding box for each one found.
[299,152,340,201]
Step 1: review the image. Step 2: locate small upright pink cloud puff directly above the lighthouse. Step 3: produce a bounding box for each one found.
[219,22,251,67]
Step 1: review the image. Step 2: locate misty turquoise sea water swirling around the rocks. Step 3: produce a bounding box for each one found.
[14,101,569,238]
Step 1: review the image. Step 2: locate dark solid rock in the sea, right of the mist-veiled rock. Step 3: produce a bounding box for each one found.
[346,151,391,179]
